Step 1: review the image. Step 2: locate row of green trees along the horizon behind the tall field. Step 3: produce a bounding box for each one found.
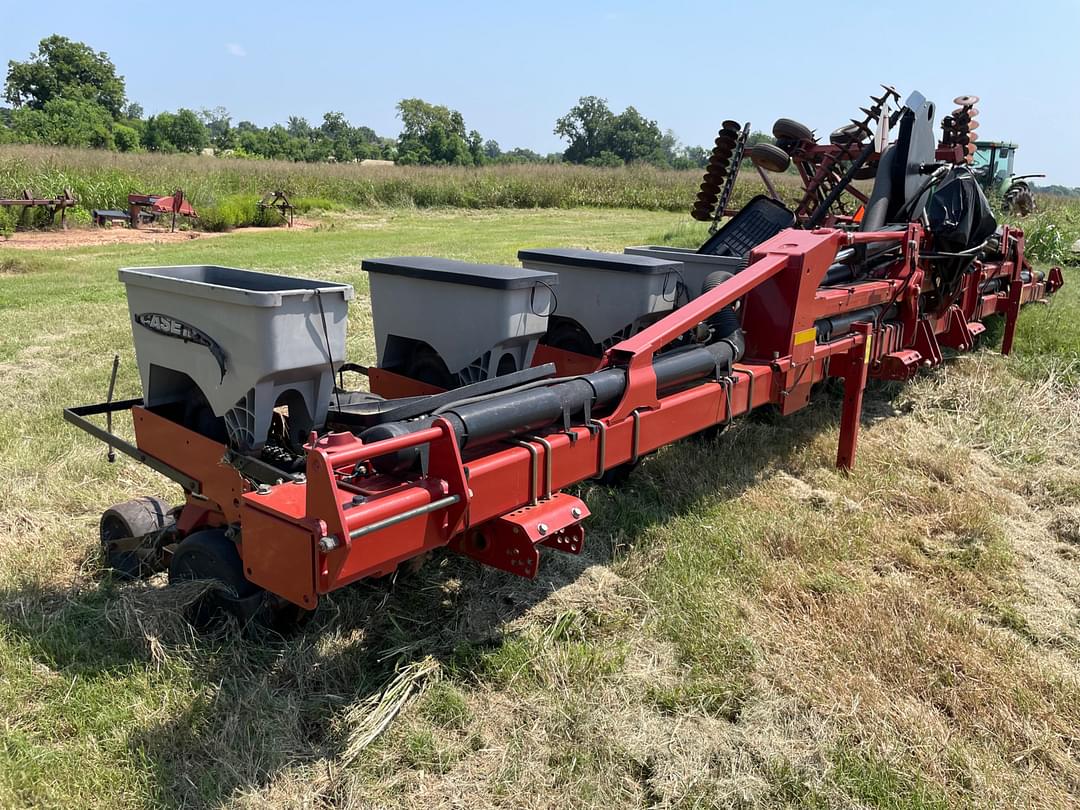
[0,35,725,168]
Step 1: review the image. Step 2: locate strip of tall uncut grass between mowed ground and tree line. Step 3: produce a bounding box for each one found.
[0,146,803,221]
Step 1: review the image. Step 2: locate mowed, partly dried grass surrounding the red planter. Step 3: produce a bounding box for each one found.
[0,210,1080,808]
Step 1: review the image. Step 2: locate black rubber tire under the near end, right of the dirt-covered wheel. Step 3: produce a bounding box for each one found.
[168,529,261,630]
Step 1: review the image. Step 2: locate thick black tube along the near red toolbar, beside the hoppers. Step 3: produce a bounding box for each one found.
[361,326,744,473]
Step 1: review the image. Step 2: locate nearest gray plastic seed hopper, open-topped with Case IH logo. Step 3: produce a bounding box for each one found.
[120,270,353,449]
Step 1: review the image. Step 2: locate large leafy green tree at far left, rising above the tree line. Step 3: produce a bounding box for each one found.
[4,35,124,118]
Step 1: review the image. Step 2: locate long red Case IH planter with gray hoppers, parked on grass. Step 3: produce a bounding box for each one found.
[65,90,1063,619]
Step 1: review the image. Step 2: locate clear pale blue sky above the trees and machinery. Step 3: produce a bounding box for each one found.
[6,0,1080,186]
